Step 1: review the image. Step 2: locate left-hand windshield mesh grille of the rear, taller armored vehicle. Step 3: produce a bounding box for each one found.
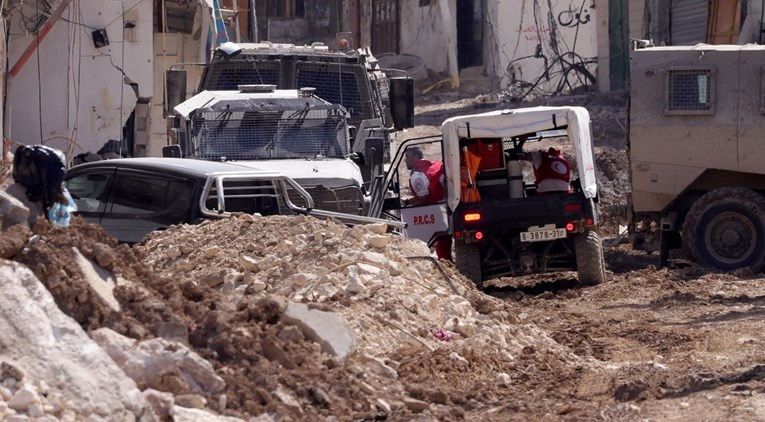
[206,60,281,91]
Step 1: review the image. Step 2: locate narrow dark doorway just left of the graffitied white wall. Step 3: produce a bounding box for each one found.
[457,0,483,69]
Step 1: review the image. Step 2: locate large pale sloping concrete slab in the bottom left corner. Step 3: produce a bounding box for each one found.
[0,261,156,420]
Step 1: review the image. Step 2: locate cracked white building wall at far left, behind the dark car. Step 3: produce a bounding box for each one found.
[6,0,154,158]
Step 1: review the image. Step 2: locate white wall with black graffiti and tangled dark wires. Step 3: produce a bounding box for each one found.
[491,0,598,98]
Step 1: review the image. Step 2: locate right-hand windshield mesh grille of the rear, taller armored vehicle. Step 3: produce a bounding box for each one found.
[295,63,372,120]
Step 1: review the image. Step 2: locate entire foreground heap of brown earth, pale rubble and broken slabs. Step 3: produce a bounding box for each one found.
[0,200,598,420]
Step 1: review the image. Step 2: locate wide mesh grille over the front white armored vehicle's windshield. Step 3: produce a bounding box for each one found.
[191,109,349,161]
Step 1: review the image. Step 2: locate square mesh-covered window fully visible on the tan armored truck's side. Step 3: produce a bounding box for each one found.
[664,68,715,115]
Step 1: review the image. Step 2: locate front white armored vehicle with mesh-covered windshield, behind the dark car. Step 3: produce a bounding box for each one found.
[166,85,374,215]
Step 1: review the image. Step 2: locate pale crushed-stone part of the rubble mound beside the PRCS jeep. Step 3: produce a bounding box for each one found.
[137,215,580,359]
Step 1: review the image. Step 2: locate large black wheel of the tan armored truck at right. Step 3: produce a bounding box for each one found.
[682,188,765,272]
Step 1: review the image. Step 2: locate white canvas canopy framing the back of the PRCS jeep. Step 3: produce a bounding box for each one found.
[441,107,598,210]
